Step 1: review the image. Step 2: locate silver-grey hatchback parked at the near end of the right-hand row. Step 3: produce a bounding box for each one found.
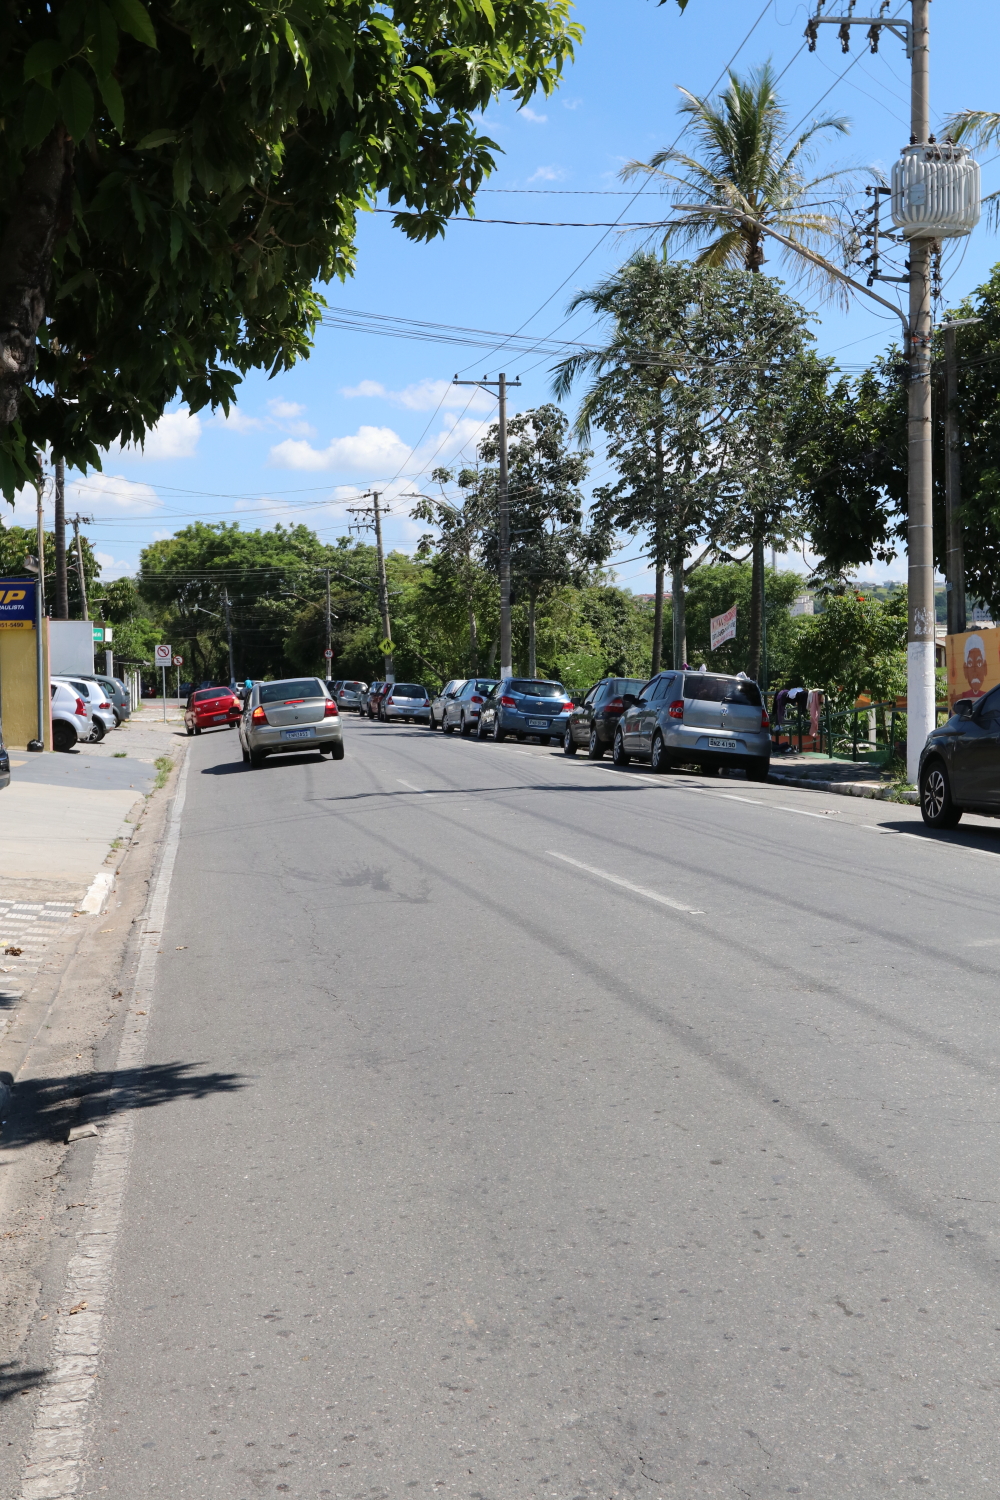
[612,672,771,782]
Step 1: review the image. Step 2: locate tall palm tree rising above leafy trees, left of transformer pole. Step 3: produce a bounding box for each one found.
[622,63,855,678]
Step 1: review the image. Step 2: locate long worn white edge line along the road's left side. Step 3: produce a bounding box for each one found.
[21,759,189,1500]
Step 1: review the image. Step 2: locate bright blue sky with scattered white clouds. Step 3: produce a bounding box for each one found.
[10,0,1000,593]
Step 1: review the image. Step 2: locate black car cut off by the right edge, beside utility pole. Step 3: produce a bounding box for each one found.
[918,687,1000,828]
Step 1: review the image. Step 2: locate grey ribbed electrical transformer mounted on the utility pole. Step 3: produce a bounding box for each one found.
[892,141,981,240]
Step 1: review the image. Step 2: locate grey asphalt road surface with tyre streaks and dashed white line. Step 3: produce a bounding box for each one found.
[70,720,1000,1500]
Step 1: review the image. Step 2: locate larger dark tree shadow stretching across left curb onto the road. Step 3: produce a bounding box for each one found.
[3,1062,246,1149]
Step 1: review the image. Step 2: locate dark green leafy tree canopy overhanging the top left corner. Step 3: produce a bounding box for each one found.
[0,0,580,497]
